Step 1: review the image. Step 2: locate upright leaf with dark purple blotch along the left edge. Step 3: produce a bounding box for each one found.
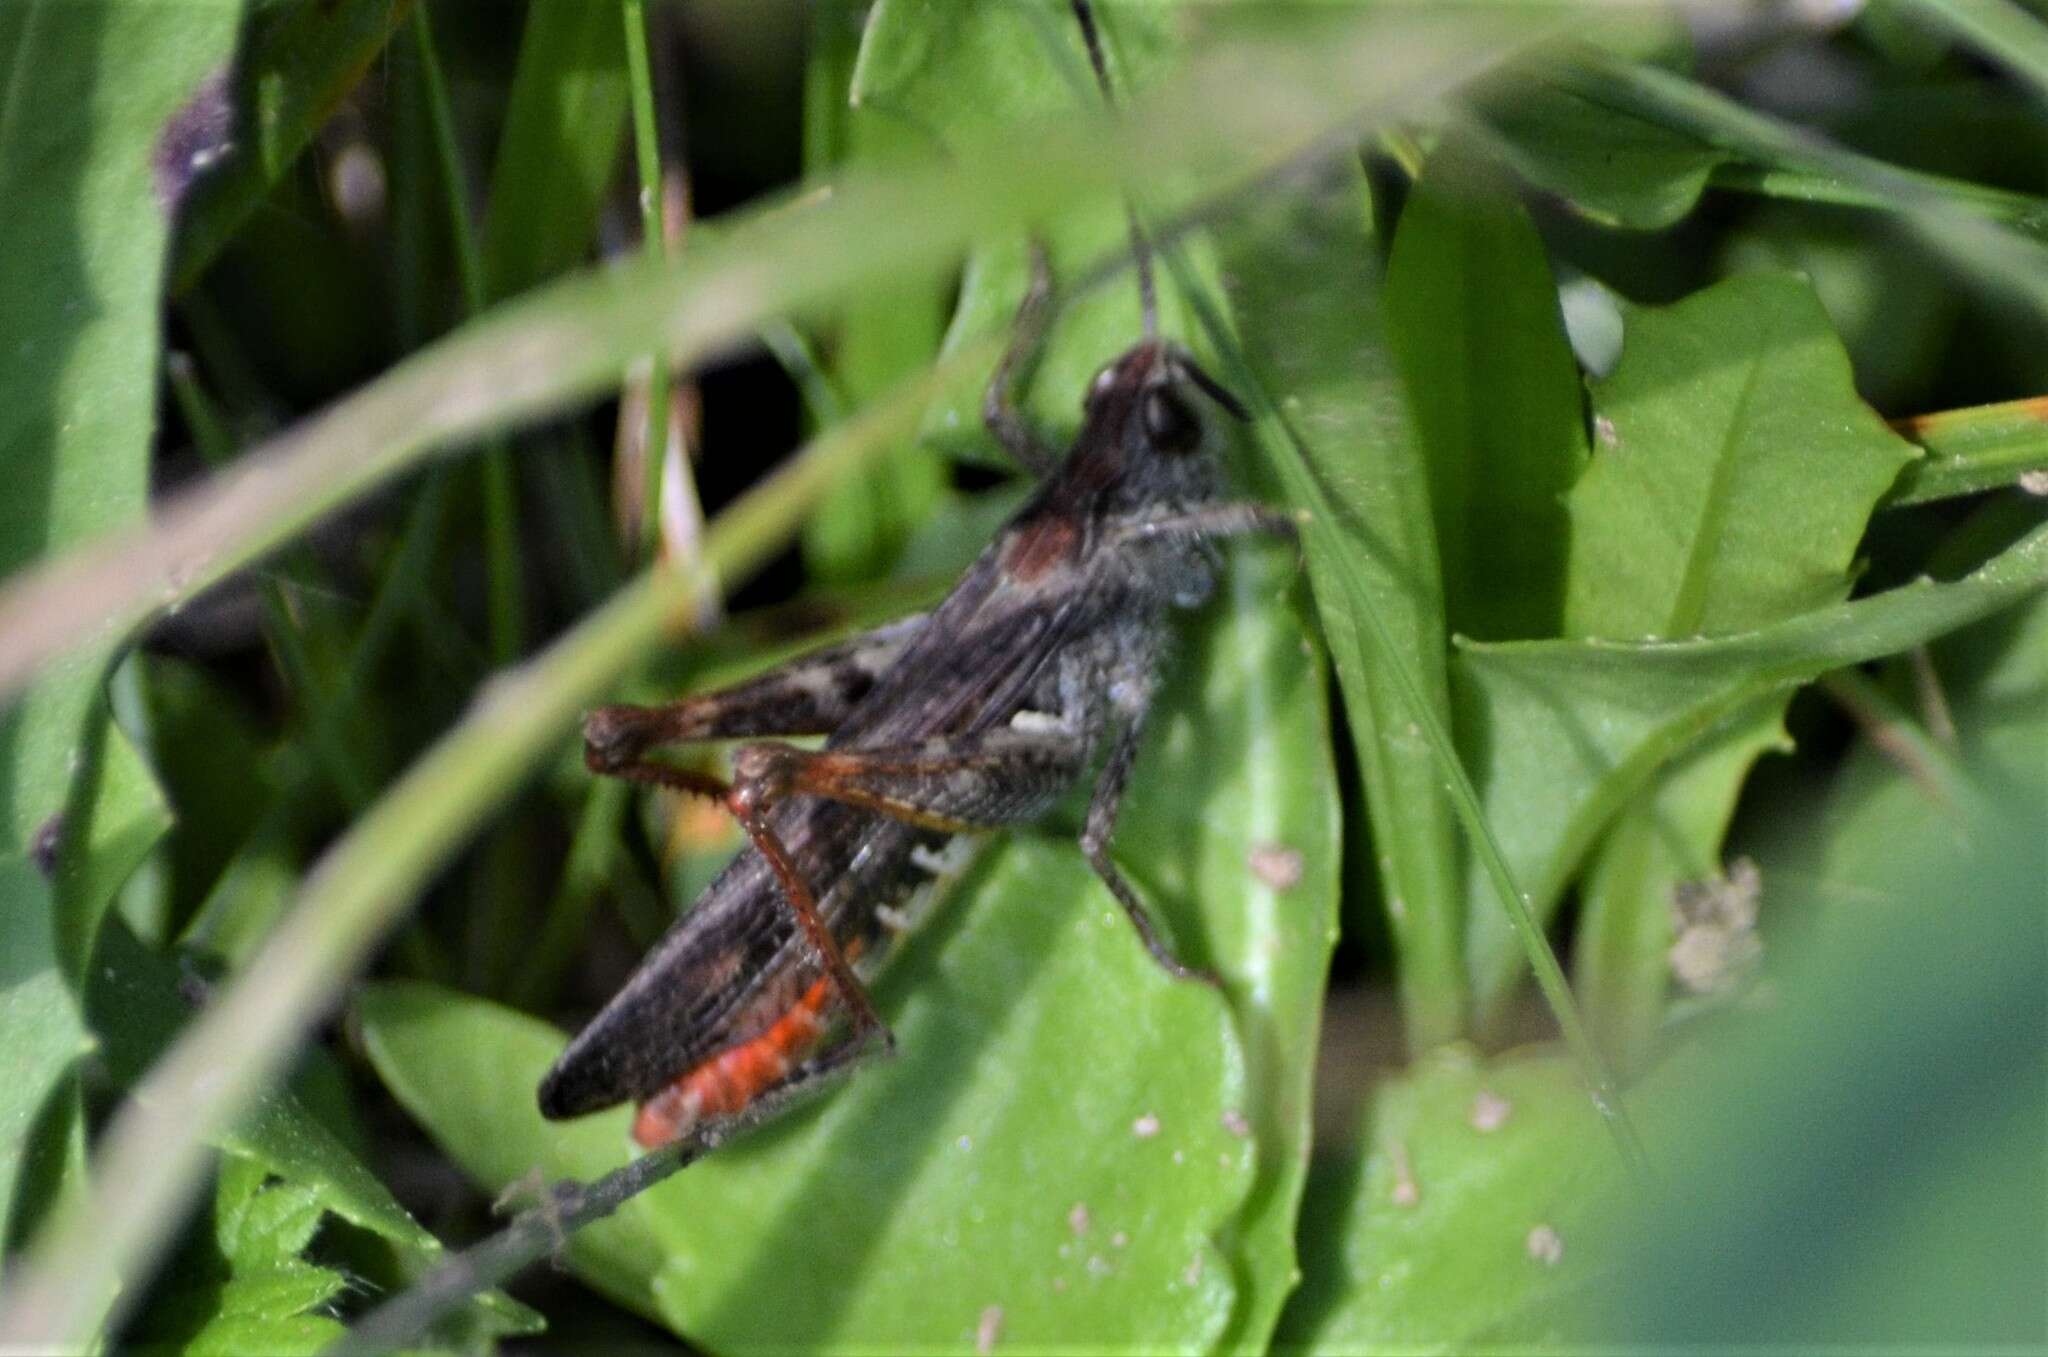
[0,0,236,933]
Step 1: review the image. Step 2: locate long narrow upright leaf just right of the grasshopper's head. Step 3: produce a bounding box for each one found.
[1223,161,1464,1050]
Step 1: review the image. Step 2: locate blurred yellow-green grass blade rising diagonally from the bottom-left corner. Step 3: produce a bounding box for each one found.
[0,344,993,1349]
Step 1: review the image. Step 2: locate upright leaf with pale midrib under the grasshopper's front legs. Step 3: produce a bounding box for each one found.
[1118,544,1341,1351]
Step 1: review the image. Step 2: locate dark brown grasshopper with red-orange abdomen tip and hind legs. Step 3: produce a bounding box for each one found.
[539,2,1292,1148]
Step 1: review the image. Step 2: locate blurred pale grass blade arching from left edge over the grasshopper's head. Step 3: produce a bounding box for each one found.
[0,10,1540,712]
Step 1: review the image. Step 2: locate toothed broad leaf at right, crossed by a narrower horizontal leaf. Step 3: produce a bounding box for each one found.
[1567,272,1913,1066]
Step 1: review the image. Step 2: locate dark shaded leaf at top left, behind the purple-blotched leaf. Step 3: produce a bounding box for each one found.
[173,0,419,293]
